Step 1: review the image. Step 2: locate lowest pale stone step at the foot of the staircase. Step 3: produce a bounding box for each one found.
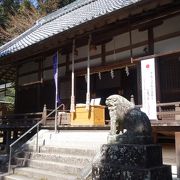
[15,167,77,180]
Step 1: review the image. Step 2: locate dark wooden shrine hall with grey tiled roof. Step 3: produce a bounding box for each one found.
[0,0,180,162]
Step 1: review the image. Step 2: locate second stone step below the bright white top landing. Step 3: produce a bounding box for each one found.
[16,152,93,166]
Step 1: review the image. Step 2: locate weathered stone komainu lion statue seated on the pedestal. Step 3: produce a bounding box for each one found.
[106,95,152,143]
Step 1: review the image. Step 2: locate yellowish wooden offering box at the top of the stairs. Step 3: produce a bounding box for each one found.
[71,105,105,126]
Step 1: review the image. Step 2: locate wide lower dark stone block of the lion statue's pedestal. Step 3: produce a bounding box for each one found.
[92,163,172,180]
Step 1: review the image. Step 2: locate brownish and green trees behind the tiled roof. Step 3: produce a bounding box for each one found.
[0,0,75,45]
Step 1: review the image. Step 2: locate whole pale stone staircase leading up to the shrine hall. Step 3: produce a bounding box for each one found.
[3,130,108,180]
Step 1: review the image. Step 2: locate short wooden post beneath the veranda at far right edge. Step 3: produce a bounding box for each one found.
[175,132,180,178]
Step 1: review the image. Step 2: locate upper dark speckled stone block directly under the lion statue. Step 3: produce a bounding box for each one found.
[99,144,162,168]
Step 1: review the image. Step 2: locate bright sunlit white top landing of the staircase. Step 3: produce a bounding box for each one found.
[27,130,108,149]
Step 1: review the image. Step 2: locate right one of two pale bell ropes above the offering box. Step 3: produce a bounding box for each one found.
[86,35,91,111]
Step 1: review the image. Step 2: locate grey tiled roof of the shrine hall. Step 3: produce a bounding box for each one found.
[0,0,140,57]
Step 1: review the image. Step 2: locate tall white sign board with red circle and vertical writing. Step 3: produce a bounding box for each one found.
[141,58,157,120]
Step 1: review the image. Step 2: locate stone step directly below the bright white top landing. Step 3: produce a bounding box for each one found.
[25,146,97,157]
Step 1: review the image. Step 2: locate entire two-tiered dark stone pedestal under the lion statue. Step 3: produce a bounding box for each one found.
[92,144,172,180]
